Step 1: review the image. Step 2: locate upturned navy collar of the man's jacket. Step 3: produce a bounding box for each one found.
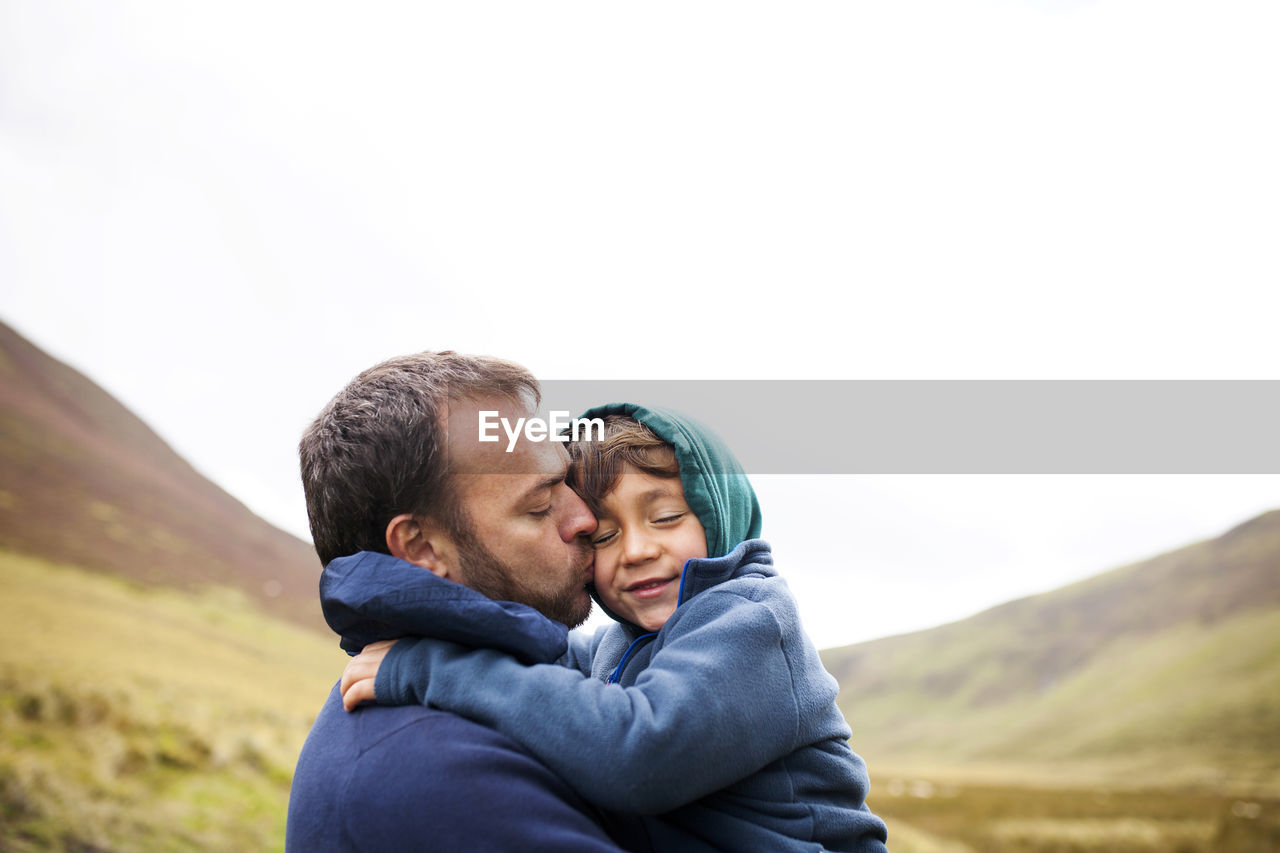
[320,551,568,663]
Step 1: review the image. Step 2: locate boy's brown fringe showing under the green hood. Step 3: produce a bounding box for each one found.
[568,415,680,516]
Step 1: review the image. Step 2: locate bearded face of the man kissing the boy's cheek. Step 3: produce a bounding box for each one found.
[449,398,595,628]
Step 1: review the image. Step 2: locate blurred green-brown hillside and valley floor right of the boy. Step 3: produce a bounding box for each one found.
[823,512,1280,853]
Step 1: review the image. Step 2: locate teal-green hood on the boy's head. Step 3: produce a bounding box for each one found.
[581,403,762,557]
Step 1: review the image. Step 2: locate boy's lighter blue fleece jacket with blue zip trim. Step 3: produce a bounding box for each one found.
[375,539,886,853]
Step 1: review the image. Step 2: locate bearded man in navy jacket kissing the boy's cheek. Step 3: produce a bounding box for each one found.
[285,352,634,852]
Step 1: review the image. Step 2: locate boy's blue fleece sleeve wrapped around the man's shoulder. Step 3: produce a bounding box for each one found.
[376,589,799,815]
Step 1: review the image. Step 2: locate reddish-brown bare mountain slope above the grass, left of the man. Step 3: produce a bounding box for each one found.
[0,317,328,630]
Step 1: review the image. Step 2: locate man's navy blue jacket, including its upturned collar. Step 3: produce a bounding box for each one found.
[285,555,634,853]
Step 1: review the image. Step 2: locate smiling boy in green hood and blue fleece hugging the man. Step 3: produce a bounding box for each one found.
[342,403,886,852]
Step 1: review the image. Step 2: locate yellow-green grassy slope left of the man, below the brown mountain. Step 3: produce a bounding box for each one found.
[0,552,346,850]
